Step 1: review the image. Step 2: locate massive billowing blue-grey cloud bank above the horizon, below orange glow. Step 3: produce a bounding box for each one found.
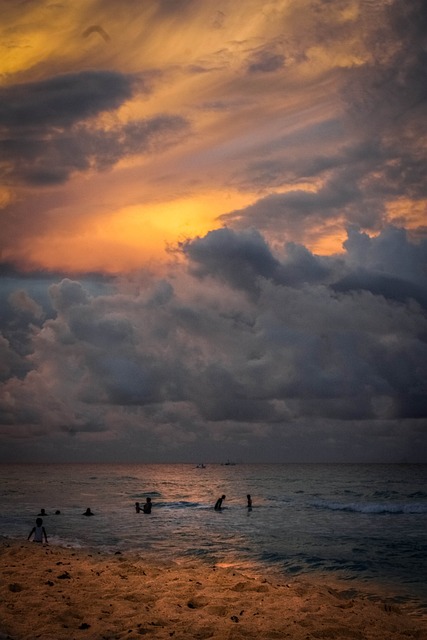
[0,228,427,460]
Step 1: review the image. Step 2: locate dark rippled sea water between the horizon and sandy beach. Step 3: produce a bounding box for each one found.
[0,464,427,608]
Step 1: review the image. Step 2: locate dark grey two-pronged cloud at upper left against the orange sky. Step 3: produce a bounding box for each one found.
[0,71,188,186]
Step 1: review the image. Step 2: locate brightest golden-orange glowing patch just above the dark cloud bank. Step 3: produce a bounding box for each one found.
[16,193,254,273]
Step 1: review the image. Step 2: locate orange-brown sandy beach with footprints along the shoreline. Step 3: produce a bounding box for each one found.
[0,539,427,640]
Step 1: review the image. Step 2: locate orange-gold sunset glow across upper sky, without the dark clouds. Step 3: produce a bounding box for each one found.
[1,0,412,272]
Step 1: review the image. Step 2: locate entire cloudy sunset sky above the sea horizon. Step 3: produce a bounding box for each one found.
[0,0,427,463]
